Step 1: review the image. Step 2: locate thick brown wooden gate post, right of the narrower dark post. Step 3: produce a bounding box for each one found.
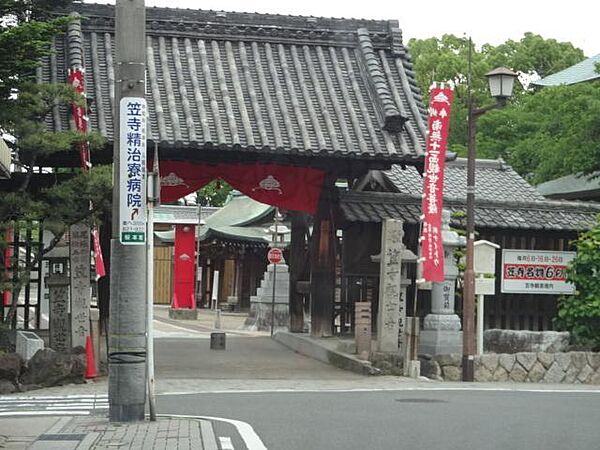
[310,180,336,337]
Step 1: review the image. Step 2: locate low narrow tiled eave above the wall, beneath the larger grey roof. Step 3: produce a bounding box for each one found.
[340,192,600,231]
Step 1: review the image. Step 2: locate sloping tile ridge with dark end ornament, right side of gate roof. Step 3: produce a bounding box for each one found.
[357,28,408,133]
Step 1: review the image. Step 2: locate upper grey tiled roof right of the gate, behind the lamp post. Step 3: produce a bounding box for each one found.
[384,158,544,202]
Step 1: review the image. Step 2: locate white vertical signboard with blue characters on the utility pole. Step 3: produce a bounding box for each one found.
[119,97,147,245]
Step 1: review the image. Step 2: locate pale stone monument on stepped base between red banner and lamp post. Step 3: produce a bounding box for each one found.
[419,210,466,355]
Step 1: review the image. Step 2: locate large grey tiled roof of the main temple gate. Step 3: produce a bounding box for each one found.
[39,4,426,162]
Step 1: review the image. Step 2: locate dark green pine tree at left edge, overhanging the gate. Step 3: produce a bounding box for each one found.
[0,0,111,321]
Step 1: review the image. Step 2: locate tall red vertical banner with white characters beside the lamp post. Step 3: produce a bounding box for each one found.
[420,85,454,282]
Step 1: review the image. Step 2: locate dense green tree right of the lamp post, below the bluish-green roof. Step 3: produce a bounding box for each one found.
[477,81,600,184]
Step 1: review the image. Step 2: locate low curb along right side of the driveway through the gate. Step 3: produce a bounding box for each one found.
[273,331,381,375]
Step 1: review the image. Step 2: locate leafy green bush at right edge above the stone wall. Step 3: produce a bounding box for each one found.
[556,217,600,350]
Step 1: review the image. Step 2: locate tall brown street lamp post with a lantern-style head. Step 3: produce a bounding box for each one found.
[462,67,518,381]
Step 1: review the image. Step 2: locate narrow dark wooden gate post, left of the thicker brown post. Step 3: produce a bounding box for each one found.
[289,213,307,333]
